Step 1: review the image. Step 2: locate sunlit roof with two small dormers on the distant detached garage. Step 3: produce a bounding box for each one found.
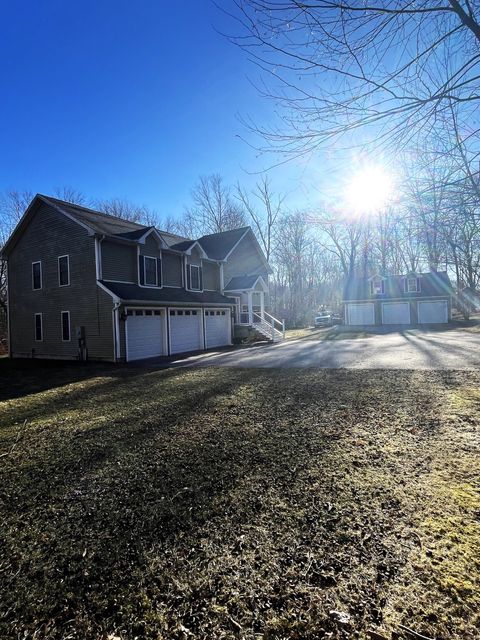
[343,271,453,300]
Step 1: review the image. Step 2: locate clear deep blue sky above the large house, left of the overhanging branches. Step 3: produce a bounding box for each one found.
[0,0,332,216]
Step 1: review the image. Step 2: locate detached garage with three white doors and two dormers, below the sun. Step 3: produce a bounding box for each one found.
[344,271,453,326]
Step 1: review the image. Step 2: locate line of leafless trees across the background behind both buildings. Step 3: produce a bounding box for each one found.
[0,151,480,326]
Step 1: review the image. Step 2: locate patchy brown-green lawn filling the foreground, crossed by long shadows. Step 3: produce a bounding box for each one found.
[0,362,480,640]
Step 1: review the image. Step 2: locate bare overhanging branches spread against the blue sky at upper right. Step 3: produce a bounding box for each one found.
[229,0,480,155]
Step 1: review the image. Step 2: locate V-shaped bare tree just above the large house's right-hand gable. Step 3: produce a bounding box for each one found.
[236,176,285,261]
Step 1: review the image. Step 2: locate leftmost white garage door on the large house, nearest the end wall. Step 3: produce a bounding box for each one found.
[125,309,166,360]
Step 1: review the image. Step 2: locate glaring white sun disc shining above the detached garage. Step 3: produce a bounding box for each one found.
[346,166,394,213]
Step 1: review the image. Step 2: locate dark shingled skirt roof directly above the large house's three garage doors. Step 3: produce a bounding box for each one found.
[101,280,234,304]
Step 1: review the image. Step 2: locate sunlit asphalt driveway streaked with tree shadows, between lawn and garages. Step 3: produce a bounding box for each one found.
[166,330,480,369]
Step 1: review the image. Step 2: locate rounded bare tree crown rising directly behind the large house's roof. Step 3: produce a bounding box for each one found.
[182,173,246,237]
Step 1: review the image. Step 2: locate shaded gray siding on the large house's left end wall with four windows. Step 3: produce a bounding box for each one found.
[8,205,113,360]
